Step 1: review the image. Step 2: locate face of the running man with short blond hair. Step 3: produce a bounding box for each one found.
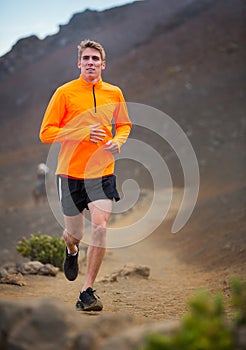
[78,47,105,82]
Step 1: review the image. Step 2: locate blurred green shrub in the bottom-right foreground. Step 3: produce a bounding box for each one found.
[139,277,246,350]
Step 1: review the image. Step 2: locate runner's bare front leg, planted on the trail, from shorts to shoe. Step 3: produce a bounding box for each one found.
[82,199,112,291]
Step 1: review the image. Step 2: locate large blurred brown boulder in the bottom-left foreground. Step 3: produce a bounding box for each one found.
[0,298,96,350]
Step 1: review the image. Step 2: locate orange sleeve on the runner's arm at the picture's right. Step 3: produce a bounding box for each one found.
[113,90,132,149]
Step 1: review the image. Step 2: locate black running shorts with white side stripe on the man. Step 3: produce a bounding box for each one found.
[57,175,120,216]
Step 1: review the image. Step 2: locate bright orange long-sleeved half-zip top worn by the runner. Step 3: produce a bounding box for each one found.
[40,76,132,179]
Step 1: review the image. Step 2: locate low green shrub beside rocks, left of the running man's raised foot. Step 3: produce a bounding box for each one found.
[16,233,65,269]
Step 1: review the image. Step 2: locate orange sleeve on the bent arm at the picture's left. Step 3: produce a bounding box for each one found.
[39,88,90,143]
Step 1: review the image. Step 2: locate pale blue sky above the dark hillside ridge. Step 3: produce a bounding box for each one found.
[0,0,139,56]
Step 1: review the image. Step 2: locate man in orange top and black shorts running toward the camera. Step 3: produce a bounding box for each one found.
[40,40,131,311]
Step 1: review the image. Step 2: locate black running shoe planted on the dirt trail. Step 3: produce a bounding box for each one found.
[76,287,103,311]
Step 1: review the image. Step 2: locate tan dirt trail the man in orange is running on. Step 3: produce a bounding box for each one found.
[0,189,240,324]
